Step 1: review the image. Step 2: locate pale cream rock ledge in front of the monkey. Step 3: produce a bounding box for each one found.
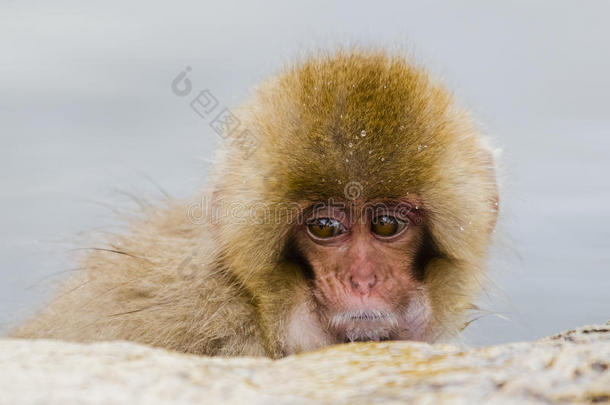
[0,322,610,405]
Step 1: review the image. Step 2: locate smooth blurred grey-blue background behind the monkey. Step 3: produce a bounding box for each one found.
[0,0,610,345]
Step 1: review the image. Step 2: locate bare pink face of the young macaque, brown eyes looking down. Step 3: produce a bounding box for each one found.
[297,196,428,342]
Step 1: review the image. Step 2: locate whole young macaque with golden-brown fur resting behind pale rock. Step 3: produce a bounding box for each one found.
[14,49,498,358]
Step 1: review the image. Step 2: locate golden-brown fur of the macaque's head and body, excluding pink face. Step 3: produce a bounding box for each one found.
[15,50,497,357]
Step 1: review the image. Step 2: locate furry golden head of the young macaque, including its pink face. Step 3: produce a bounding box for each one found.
[210,50,498,356]
